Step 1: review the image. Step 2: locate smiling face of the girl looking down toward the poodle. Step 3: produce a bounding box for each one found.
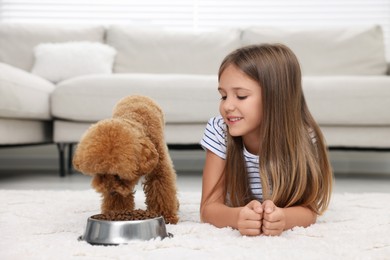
[218,65,263,152]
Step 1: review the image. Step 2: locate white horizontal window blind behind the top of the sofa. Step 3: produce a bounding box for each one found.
[0,0,390,57]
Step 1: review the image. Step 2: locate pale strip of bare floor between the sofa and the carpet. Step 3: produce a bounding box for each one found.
[0,170,390,193]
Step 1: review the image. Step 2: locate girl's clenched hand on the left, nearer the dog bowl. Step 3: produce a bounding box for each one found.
[237,200,263,236]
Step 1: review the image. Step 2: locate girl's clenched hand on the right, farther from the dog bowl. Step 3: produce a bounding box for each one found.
[262,200,286,236]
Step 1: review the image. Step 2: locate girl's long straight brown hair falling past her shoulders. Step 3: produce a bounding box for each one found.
[219,44,333,214]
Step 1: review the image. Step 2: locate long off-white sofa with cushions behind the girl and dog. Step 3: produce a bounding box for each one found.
[0,23,390,176]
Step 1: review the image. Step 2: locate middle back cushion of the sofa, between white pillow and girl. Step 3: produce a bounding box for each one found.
[107,25,240,75]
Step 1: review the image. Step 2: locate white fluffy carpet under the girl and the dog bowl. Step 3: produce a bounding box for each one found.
[0,190,390,260]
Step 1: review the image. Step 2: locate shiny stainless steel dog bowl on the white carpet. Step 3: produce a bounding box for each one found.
[79,214,172,245]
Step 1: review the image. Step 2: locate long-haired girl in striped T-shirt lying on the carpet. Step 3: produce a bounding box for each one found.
[200,44,333,236]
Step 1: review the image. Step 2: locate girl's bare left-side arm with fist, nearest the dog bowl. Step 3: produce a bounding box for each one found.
[200,150,262,235]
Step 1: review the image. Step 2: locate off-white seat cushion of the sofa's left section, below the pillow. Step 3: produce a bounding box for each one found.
[0,63,55,120]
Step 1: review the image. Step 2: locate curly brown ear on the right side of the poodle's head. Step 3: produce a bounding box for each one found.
[139,138,159,174]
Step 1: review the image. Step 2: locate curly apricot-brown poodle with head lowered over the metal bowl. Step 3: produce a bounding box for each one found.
[73,95,179,224]
